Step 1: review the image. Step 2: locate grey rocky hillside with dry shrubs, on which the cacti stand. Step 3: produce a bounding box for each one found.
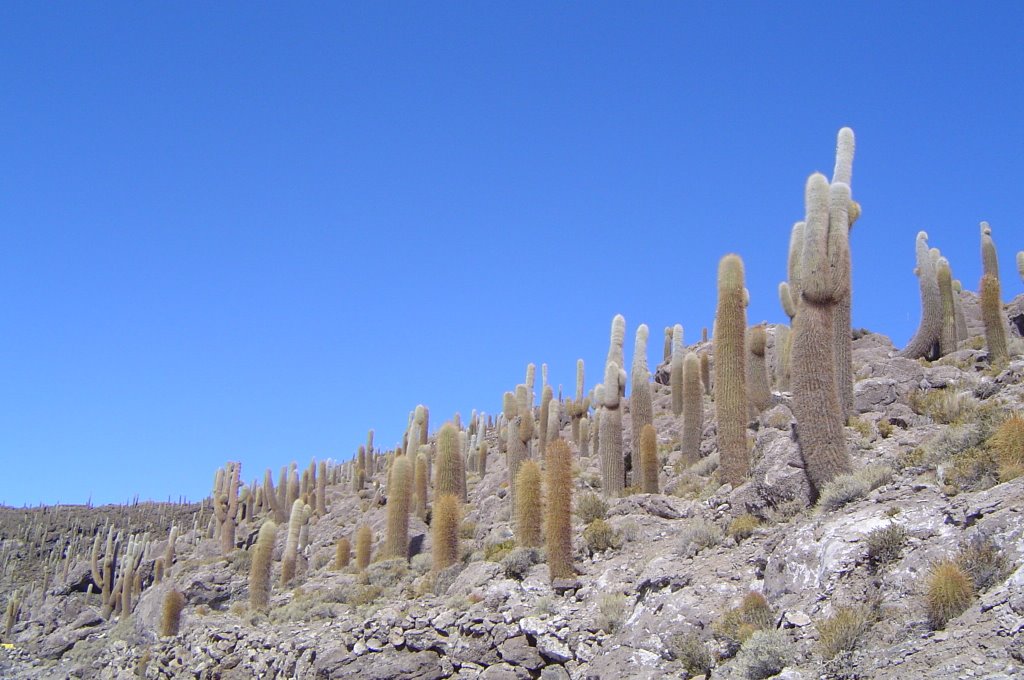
[0,293,1024,679]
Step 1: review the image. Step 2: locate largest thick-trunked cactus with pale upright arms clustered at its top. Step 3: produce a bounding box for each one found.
[793,173,856,495]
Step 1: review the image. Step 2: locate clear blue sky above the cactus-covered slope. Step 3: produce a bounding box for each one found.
[0,2,1024,505]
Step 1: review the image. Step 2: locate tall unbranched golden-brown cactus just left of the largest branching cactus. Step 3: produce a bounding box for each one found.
[714,254,750,486]
